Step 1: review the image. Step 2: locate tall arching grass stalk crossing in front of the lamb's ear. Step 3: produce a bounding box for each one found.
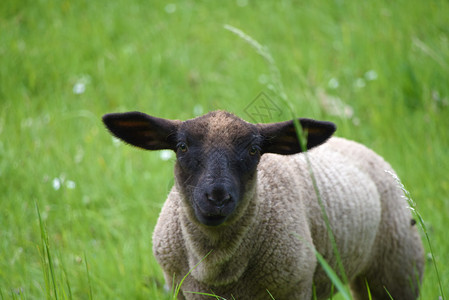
[224,24,351,299]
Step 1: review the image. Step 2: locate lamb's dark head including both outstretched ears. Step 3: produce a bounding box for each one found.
[103,111,335,226]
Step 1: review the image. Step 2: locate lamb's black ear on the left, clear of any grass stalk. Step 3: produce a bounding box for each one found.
[103,112,181,150]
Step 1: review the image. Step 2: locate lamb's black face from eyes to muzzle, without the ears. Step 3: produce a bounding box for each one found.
[176,125,262,226]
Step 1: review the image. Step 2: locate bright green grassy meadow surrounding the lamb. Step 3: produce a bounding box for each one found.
[0,0,449,299]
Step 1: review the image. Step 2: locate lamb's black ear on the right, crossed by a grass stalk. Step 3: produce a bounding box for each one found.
[258,119,336,154]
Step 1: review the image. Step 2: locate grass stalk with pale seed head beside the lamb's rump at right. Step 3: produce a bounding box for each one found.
[385,171,446,300]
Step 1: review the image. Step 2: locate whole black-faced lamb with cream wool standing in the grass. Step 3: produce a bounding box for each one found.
[103,111,424,300]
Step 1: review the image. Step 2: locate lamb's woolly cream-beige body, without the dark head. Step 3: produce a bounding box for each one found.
[153,138,423,300]
